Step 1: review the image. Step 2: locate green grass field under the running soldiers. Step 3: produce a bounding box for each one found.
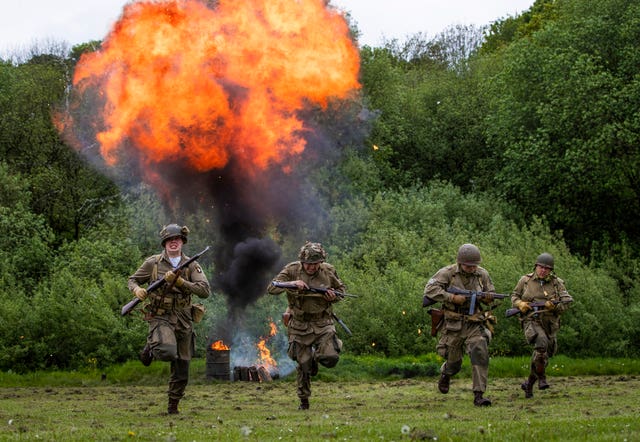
[0,358,640,441]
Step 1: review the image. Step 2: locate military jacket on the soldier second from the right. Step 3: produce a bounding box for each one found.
[424,264,495,312]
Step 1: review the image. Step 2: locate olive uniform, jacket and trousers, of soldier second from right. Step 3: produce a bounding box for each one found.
[424,264,495,393]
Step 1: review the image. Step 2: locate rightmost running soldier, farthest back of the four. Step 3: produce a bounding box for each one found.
[511,253,573,398]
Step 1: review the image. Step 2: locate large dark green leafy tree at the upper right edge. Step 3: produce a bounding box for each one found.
[485,0,640,255]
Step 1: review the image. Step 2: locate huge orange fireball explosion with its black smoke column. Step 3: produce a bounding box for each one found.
[57,0,360,317]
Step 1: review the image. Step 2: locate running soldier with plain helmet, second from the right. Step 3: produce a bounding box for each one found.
[424,244,495,406]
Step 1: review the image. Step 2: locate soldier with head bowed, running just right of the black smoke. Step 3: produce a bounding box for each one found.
[267,242,345,410]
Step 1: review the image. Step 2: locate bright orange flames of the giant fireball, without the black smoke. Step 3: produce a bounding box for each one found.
[62,0,360,185]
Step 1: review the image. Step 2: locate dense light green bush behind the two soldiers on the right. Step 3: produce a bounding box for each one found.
[335,183,637,356]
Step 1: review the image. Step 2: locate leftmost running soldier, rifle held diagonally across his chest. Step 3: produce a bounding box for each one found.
[128,224,211,414]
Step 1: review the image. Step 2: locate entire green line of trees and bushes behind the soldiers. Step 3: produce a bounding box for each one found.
[0,0,640,371]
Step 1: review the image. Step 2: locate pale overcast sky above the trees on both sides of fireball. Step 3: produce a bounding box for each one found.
[0,0,534,55]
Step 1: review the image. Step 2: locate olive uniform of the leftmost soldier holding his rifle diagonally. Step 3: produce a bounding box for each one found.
[128,251,211,400]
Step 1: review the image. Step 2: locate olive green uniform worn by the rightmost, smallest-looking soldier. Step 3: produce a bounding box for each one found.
[511,272,573,376]
